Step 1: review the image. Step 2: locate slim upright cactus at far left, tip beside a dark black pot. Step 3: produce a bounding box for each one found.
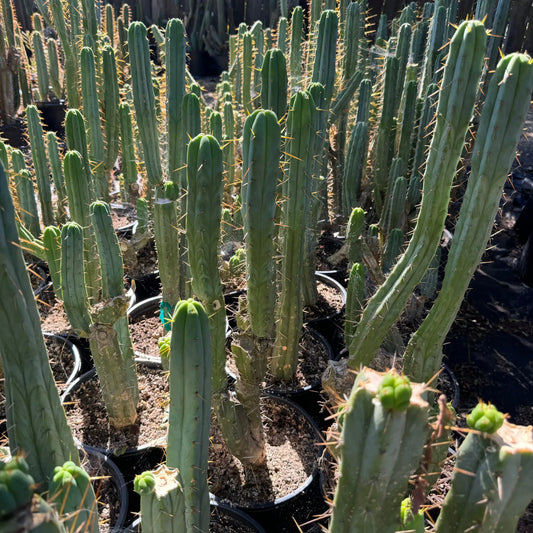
[26,105,54,226]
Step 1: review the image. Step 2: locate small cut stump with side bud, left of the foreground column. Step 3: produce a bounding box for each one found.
[133,465,188,533]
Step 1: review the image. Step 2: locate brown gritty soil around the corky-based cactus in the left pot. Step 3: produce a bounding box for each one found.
[65,365,168,453]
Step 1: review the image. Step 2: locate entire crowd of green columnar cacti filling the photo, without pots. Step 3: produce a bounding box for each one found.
[0,0,533,533]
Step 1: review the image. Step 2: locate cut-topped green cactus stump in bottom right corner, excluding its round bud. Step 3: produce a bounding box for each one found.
[435,418,533,533]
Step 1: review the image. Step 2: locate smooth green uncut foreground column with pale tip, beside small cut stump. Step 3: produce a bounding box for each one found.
[167,299,212,533]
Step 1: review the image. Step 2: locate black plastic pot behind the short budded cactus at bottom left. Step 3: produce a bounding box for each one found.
[80,450,129,533]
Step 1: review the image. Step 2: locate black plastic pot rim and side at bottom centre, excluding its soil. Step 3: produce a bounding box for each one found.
[211,395,328,533]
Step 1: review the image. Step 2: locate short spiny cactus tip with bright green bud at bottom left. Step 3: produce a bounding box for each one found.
[48,461,99,533]
